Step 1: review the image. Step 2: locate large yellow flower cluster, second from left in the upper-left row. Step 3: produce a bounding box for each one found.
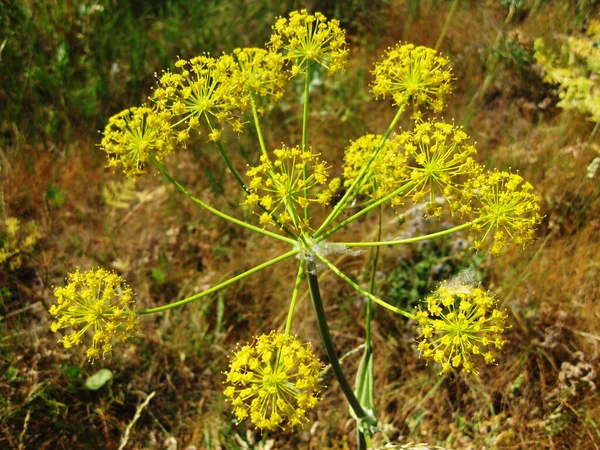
[152,55,242,136]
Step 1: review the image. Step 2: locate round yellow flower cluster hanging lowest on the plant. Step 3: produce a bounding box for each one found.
[225,331,323,430]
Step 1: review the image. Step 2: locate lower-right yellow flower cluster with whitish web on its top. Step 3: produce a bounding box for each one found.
[417,283,506,375]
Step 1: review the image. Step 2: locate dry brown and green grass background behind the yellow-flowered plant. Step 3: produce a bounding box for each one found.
[0,0,600,450]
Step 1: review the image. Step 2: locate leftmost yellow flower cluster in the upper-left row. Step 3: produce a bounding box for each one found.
[100,106,176,179]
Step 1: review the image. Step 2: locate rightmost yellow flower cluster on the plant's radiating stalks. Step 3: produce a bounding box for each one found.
[471,171,541,254]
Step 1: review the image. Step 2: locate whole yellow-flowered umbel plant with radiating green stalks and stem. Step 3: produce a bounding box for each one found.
[50,10,540,449]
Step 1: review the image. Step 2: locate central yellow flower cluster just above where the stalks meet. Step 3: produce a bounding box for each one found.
[244,145,340,231]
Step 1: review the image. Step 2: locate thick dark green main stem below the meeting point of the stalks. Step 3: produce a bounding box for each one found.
[307,261,367,434]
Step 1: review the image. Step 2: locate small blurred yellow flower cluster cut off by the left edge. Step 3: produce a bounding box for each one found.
[0,217,42,270]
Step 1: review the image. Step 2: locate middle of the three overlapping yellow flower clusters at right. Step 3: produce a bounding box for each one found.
[397,122,482,217]
